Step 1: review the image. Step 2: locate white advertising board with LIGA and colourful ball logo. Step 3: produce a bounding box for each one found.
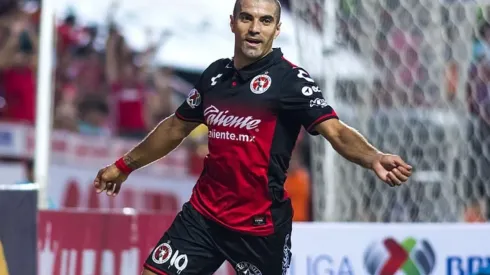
[288,223,490,275]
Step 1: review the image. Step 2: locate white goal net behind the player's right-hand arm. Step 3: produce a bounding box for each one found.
[291,0,490,222]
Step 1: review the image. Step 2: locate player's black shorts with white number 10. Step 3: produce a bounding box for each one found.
[144,203,292,275]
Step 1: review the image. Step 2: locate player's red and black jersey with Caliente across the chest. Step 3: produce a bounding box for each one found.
[176,49,337,236]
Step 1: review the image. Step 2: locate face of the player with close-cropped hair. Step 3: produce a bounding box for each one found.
[230,0,280,59]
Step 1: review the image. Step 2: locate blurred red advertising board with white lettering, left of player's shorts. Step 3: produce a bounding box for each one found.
[38,211,234,275]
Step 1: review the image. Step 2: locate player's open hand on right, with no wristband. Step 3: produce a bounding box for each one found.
[371,154,412,186]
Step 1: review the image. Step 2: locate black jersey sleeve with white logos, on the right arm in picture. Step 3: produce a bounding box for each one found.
[280,68,338,135]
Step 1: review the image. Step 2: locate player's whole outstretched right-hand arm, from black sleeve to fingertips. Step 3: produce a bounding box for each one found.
[281,68,412,186]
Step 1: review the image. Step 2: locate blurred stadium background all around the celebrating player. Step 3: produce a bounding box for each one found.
[0,0,490,275]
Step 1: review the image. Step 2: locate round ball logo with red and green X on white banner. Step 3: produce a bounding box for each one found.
[364,237,436,275]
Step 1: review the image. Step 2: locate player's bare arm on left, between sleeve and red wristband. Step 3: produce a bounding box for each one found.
[122,115,200,170]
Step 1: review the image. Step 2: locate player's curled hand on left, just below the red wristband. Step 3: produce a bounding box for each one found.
[94,164,128,196]
